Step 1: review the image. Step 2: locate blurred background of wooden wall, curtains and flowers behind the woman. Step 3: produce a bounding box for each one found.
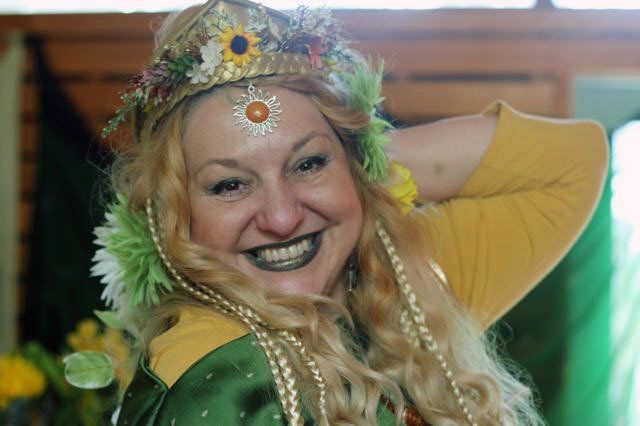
[0,0,640,426]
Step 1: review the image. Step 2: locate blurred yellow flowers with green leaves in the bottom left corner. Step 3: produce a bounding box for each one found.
[0,319,131,426]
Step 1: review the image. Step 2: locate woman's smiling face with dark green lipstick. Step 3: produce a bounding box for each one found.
[183,86,362,295]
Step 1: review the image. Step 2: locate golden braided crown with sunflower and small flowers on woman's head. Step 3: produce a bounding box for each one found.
[103,0,353,137]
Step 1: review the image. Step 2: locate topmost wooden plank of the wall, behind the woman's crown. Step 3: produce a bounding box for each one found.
[0,9,640,40]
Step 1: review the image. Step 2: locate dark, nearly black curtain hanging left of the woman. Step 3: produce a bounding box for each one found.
[21,39,107,350]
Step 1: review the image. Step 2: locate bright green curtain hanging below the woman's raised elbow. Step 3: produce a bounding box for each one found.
[500,166,613,426]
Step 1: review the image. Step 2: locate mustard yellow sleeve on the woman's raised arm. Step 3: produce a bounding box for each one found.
[418,102,609,327]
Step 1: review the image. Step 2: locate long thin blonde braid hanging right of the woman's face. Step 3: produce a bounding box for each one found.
[376,221,478,426]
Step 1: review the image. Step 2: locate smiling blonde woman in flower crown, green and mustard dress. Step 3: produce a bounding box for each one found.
[89,0,607,425]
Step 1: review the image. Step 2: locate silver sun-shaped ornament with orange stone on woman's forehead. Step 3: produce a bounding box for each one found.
[233,83,282,136]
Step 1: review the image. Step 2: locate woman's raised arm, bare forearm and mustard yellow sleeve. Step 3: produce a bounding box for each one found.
[390,103,608,327]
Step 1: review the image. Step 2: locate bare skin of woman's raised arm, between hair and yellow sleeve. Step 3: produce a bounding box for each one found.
[387,115,498,201]
